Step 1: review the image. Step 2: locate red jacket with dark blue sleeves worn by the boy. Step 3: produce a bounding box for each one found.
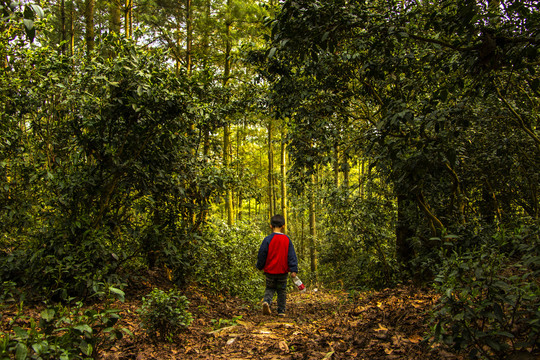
[257,233,298,274]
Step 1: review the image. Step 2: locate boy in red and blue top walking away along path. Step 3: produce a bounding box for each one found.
[257,215,298,316]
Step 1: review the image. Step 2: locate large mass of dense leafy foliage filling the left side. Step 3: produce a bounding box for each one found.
[1,36,224,298]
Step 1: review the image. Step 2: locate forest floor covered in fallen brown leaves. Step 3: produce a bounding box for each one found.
[0,273,463,360]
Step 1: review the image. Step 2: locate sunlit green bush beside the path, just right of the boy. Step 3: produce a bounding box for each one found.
[318,190,397,290]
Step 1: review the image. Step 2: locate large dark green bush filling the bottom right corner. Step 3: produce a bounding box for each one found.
[433,226,540,359]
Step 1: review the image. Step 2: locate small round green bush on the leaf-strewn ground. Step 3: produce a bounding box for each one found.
[139,289,193,341]
